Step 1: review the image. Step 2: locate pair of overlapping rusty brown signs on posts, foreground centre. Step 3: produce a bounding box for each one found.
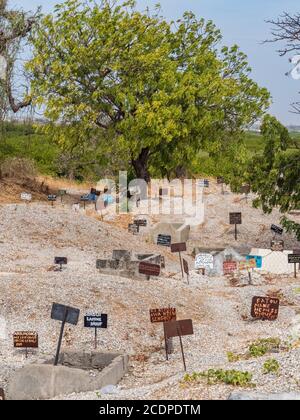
[150,307,194,370]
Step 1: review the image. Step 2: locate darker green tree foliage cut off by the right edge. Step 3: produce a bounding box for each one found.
[245,115,300,240]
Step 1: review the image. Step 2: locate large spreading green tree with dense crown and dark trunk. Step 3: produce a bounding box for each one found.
[29,0,269,181]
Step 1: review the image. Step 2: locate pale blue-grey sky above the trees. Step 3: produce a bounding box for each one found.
[10,0,300,125]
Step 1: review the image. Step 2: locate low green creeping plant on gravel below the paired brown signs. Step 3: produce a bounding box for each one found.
[183,369,255,387]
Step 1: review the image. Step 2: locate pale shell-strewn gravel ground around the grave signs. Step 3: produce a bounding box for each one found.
[0,187,300,400]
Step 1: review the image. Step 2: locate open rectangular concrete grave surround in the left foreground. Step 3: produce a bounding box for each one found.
[7,352,128,400]
